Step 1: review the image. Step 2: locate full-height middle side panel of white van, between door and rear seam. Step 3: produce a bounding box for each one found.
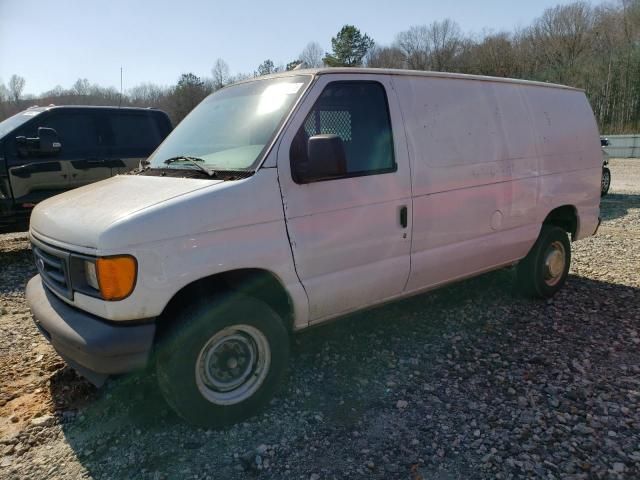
[394,77,538,290]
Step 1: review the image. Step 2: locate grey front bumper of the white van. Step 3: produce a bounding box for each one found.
[26,275,156,386]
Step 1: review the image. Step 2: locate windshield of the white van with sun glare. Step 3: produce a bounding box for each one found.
[149,75,311,171]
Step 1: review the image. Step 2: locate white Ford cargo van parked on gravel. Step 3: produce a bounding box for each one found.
[27,69,602,426]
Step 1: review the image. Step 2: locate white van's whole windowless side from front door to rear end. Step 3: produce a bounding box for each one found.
[394,76,599,291]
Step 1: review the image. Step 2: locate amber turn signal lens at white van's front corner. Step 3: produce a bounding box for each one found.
[96,255,138,300]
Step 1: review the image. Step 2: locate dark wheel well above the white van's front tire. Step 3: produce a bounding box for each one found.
[157,268,293,335]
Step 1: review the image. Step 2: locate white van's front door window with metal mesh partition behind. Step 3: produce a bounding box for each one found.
[289,81,396,183]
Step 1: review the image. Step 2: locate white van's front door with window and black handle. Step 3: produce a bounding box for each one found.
[278,75,411,323]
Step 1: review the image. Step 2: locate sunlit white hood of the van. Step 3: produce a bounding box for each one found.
[30,175,222,249]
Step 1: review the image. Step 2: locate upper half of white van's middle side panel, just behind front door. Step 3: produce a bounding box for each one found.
[394,77,537,195]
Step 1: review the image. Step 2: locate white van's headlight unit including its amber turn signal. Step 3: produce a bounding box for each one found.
[72,255,138,301]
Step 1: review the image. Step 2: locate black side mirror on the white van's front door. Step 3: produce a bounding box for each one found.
[294,134,347,183]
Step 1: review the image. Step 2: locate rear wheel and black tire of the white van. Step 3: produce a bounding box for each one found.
[516,225,571,298]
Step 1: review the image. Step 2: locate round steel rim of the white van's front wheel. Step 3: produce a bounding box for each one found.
[195,325,271,405]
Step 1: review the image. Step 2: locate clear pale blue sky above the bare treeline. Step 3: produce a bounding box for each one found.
[0,0,596,94]
